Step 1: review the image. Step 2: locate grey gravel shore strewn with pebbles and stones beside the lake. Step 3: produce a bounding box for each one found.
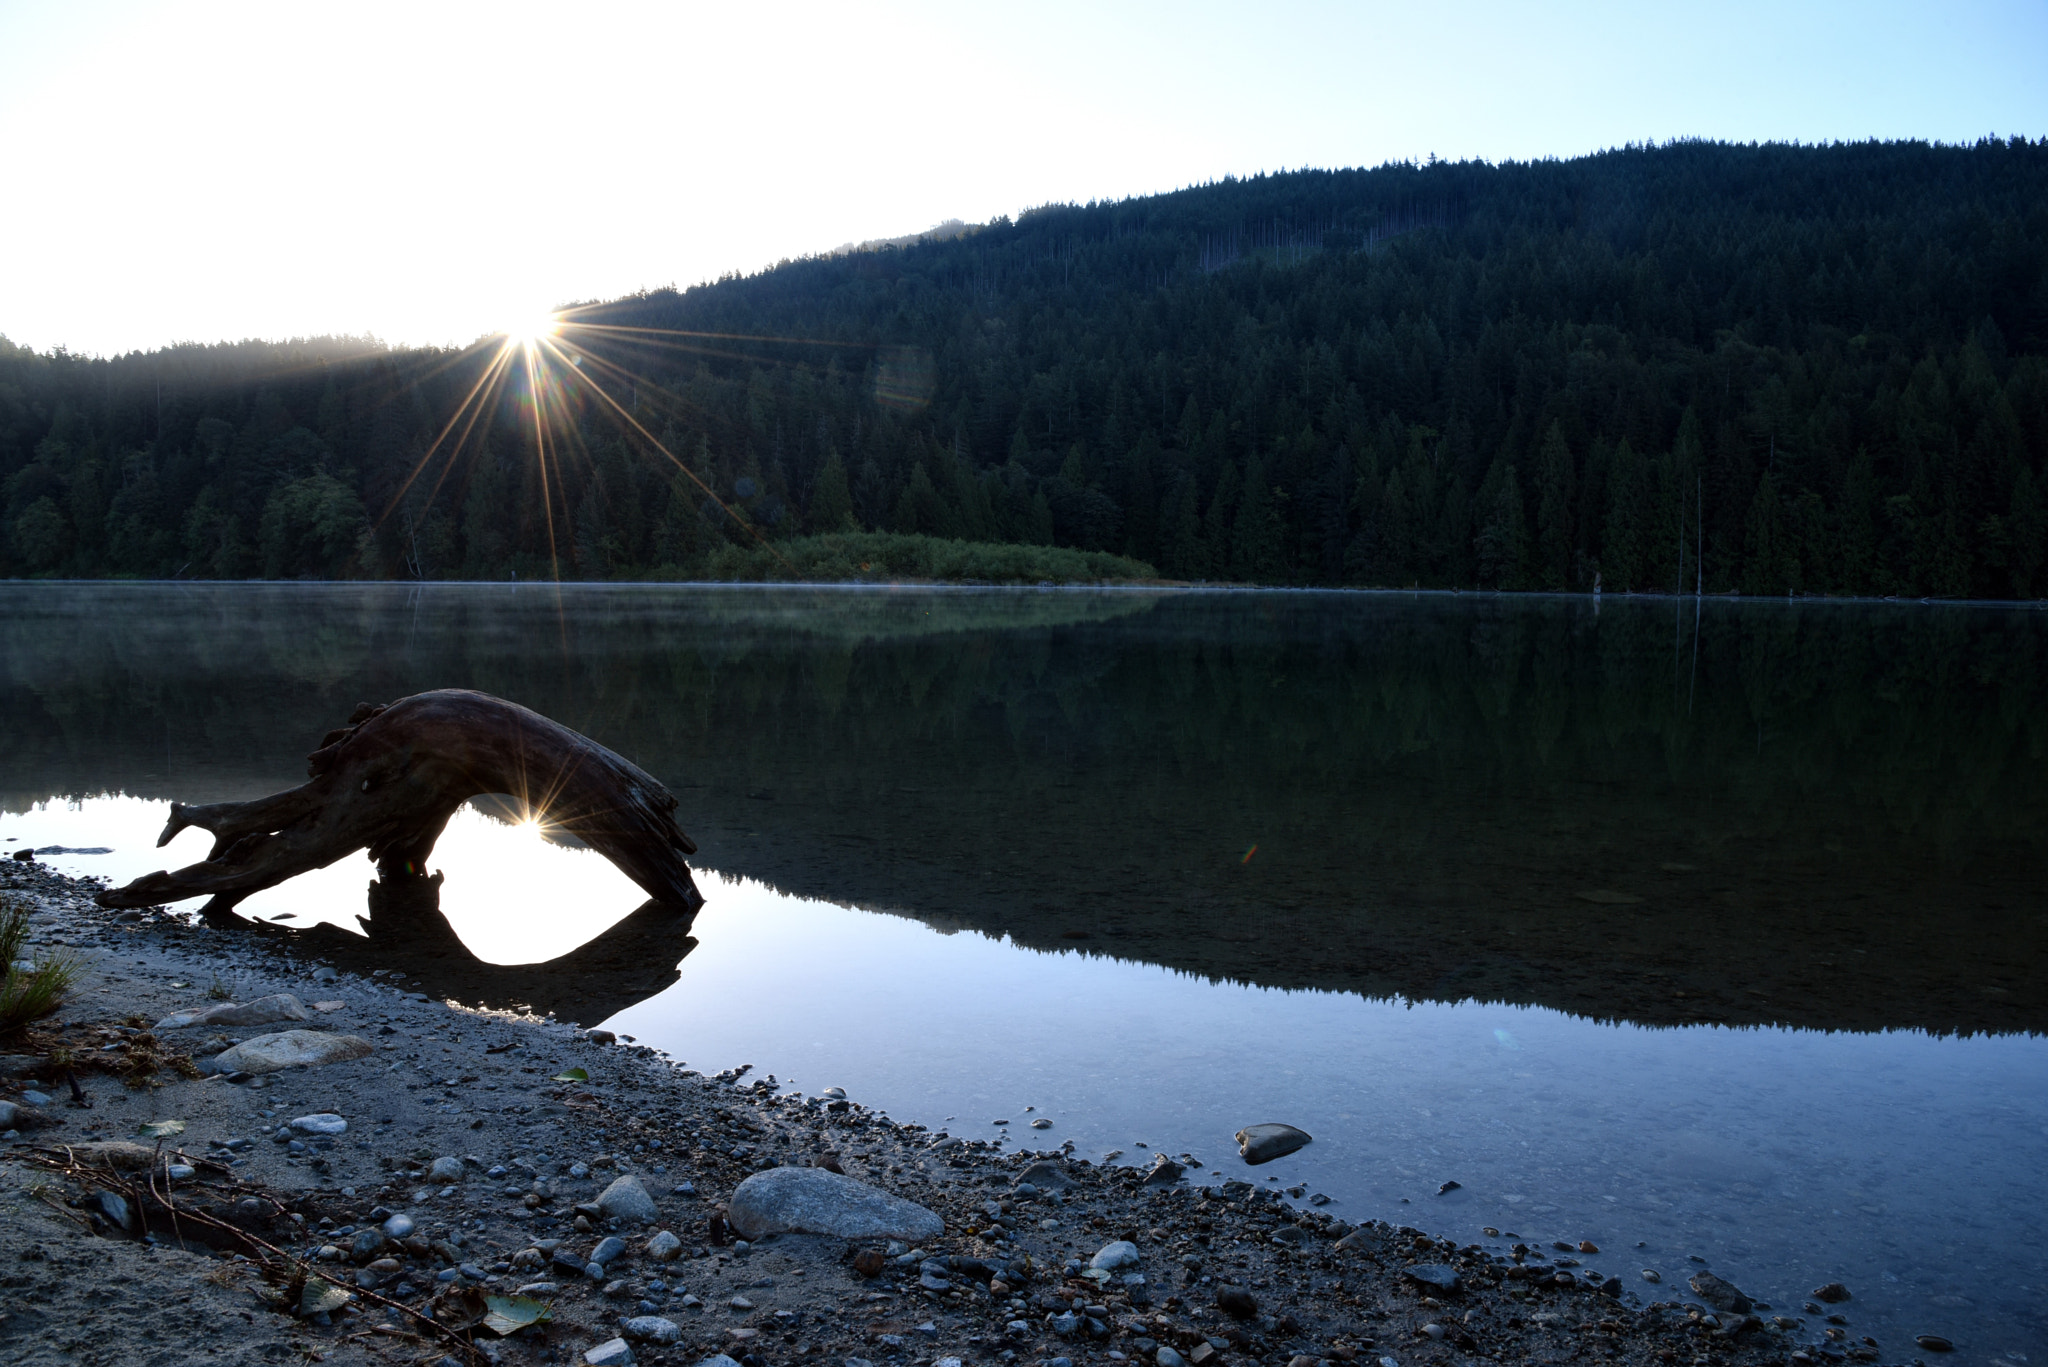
[0,861,1921,1367]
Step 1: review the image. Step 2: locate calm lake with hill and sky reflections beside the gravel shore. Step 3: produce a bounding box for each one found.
[0,584,2048,1361]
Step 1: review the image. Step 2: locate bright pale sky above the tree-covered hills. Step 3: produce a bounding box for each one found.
[0,0,2048,355]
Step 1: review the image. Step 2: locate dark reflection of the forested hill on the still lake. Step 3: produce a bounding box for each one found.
[0,586,2048,1031]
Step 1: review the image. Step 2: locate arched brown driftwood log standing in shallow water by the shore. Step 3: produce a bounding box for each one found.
[98,689,705,914]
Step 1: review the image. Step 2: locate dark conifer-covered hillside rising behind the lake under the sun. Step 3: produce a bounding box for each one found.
[12,139,2048,598]
